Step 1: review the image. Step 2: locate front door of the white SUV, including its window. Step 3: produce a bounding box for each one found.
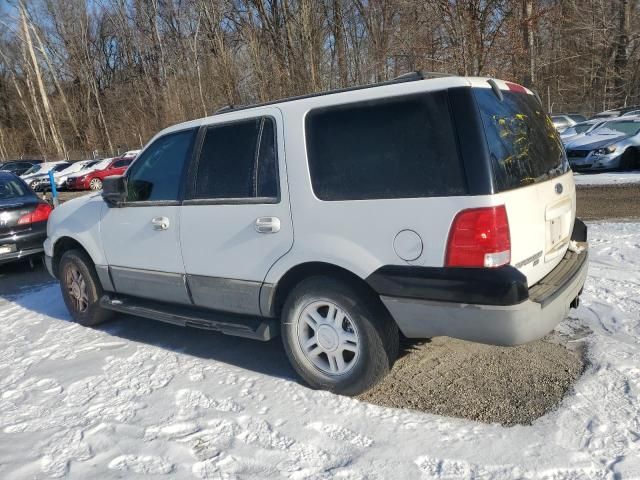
[100,129,197,304]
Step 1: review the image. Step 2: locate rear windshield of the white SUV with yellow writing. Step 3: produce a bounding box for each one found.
[474,88,569,191]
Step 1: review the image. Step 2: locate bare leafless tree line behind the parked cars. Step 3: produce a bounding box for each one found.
[0,0,640,159]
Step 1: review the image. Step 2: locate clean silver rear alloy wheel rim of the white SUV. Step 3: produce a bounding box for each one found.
[297,300,361,376]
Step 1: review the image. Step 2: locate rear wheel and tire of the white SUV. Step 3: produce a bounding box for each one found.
[281,277,399,395]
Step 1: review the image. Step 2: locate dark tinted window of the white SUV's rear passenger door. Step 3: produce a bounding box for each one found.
[194,117,278,199]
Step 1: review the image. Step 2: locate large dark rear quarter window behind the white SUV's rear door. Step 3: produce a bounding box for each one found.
[306,91,466,200]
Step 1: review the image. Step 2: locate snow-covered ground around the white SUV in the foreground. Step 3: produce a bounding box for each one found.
[0,223,640,480]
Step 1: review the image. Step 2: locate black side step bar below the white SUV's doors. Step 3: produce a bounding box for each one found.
[100,294,280,342]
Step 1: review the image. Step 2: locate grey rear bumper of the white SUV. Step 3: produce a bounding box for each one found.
[380,220,589,345]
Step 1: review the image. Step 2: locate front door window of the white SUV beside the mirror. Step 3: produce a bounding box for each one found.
[125,130,195,202]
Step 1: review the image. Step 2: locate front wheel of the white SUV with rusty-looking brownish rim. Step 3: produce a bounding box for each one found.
[58,250,111,327]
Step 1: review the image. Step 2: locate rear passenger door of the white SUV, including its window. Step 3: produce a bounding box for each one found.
[180,108,293,314]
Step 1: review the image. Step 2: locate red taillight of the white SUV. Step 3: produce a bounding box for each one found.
[446,205,511,268]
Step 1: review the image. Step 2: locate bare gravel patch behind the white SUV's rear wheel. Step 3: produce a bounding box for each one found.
[360,333,585,425]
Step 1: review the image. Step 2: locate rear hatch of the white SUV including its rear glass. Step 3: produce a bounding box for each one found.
[474,82,576,286]
